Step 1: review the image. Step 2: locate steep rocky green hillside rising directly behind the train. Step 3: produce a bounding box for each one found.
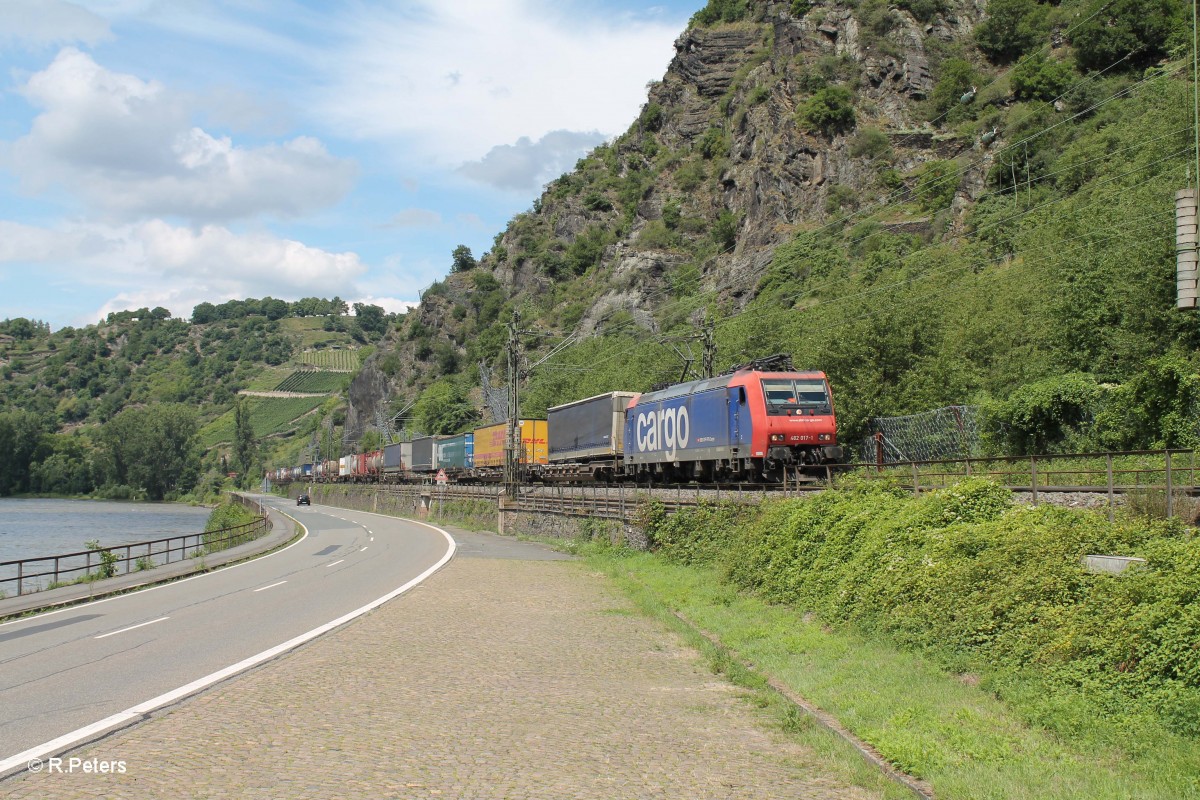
[362,0,1200,449]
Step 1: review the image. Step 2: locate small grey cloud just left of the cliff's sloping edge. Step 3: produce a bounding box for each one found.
[458,131,605,192]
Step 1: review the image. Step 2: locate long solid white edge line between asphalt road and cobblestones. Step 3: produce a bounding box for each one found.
[0,519,457,776]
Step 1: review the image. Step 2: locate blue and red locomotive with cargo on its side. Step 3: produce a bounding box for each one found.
[625,365,844,482]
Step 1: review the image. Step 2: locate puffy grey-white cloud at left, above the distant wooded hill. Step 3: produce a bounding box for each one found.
[11,48,355,222]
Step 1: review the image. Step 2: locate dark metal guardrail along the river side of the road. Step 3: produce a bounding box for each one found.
[0,495,270,596]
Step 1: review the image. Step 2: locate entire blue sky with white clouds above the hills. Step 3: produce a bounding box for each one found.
[0,0,703,330]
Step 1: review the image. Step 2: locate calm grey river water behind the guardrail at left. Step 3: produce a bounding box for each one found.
[0,498,211,561]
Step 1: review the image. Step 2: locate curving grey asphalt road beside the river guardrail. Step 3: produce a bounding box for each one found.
[0,498,458,775]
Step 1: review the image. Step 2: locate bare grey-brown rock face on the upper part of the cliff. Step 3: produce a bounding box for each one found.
[350,0,986,434]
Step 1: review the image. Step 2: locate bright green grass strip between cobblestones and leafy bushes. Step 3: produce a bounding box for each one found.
[582,548,1200,800]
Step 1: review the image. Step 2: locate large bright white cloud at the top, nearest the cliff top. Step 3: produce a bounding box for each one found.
[314,0,683,164]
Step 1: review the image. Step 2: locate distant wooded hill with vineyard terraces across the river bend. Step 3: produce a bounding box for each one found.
[0,297,395,499]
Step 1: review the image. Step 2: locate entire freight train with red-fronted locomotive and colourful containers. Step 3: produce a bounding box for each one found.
[268,356,844,483]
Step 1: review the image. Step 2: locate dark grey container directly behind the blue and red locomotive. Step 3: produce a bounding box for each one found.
[546,392,637,464]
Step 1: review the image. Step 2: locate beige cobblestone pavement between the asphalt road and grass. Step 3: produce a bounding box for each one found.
[0,559,875,800]
